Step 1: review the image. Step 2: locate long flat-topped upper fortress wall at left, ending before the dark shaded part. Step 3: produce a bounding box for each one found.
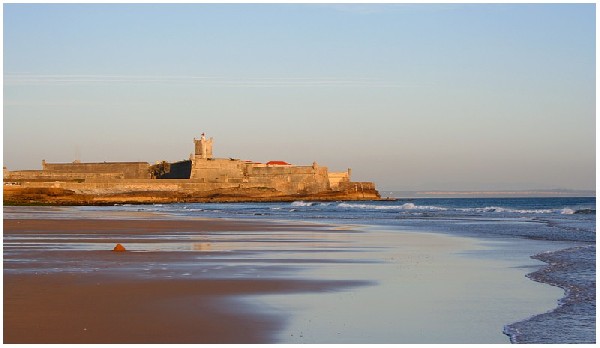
[42,162,150,179]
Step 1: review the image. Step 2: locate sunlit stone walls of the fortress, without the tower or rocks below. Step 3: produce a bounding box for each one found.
[5,157,330,194]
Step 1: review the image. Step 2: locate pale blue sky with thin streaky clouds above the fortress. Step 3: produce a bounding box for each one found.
[3,3,596,190]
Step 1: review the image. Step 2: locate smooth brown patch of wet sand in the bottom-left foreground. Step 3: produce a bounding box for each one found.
[4,274,366,343]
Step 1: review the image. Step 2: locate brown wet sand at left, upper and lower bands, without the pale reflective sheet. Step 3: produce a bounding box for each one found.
[4,219,361,343]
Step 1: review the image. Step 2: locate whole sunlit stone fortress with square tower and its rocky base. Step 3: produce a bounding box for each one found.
[4,133,380,204]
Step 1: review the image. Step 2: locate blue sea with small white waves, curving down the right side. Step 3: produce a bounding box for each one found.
[23,198,596,343]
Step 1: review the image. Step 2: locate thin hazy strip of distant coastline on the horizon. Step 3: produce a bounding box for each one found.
[380,189,596,198]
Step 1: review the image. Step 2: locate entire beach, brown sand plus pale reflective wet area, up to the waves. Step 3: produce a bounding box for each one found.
[4,211,562,343]
